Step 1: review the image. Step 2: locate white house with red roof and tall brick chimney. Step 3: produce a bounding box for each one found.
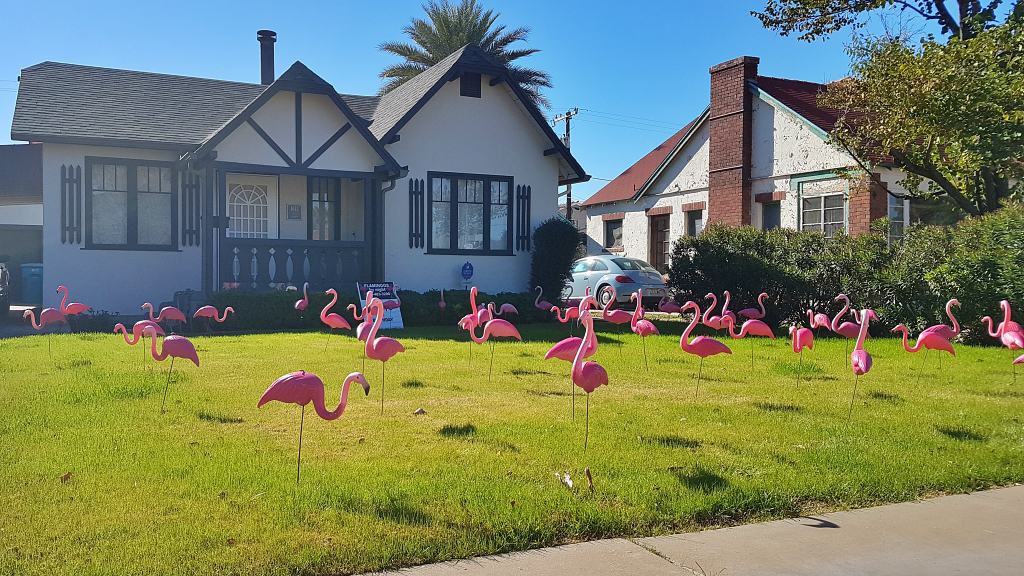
[583,56,908,271]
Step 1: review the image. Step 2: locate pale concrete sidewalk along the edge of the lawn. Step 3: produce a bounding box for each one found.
[366,486,1024,576]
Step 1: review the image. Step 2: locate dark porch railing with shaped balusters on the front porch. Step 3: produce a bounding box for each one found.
[219,238,369,292]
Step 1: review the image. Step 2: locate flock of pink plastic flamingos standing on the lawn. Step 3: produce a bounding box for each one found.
[25,284,1024,481]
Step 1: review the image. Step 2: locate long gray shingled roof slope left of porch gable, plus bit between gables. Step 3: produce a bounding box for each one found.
[10,61,380,149]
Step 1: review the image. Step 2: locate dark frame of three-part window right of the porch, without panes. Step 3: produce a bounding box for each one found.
[424,171,515,256]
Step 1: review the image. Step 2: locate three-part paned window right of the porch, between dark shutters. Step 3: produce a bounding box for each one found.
[428,172,512,253]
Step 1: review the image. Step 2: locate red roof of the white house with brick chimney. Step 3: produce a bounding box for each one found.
[583,76,839,206]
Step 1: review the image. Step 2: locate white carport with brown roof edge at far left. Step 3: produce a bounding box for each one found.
[0,145,43,303]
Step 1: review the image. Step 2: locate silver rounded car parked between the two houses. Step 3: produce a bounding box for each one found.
[568,255,668,306]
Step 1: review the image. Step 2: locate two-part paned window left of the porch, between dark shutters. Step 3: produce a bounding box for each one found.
[86,158,177,250]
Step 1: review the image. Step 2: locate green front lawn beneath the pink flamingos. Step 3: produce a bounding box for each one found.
[0,323,1024,575]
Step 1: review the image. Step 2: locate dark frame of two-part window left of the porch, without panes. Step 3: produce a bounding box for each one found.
[82,156,181,252]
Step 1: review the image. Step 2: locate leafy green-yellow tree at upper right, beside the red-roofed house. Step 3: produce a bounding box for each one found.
[754,0,1024,214]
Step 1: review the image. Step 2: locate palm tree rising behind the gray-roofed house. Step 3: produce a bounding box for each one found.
[380,0,551,108]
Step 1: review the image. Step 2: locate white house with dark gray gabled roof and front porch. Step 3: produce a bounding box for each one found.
[11,31,589,313]
